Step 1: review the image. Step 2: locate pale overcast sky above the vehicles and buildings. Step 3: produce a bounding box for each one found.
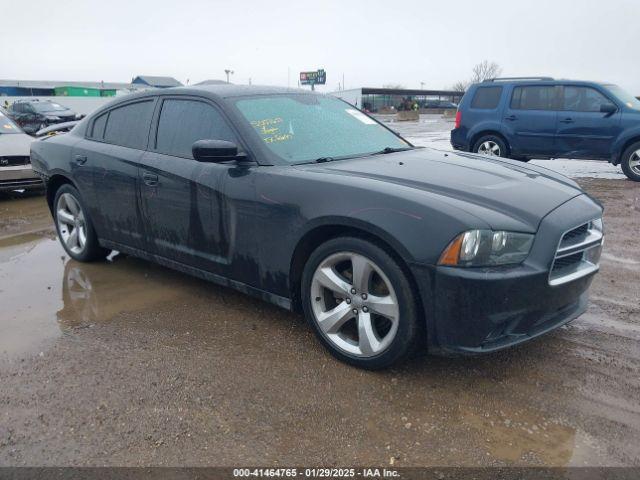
[0,0,640,95]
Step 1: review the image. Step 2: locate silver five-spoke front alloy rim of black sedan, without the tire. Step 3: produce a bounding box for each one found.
[311,252,400,357]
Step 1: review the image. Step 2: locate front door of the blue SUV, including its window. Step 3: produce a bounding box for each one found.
[557,85,621,159]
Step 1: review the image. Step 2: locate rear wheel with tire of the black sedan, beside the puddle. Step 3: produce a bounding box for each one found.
[53,184,110,262]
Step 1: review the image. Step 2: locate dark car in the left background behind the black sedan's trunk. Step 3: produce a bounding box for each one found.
[9,99,82,133]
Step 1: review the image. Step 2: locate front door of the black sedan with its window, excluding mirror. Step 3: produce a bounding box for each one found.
[140,96,238,274]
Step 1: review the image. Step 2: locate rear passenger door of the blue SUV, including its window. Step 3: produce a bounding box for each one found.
[503,85,558,157]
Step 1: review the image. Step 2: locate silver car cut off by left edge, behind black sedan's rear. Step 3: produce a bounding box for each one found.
[0,111,44,192]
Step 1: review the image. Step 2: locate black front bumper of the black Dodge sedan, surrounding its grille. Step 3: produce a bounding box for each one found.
[412,195,602,354]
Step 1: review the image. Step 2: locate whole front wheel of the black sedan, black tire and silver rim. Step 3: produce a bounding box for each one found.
[301,237,421,370]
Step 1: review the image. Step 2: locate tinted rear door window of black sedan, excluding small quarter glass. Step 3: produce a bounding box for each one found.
[105,100,153,150]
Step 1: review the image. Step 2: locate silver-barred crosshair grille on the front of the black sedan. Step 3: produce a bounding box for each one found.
[549,219,603,285]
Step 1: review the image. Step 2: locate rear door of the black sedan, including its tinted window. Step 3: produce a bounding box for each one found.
[72,97,156,249]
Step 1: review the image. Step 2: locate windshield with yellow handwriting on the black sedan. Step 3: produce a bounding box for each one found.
[236,94,411,163]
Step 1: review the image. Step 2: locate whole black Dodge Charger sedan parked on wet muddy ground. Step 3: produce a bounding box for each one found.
[31,85,603,369]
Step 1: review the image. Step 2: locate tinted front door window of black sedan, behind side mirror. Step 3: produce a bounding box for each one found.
[156,99,236,158]
